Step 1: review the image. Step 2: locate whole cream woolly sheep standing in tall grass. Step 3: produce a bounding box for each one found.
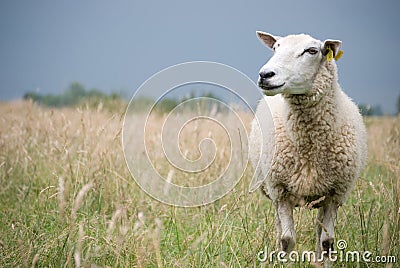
[249,32,367,256]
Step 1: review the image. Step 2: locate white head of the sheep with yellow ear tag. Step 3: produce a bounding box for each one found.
[257,32,341,95]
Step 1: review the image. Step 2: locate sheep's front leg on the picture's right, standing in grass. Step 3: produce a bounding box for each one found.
[318,201,339,252]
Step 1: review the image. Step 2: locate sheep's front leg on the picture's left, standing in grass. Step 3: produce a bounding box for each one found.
[277,200,296,252]
